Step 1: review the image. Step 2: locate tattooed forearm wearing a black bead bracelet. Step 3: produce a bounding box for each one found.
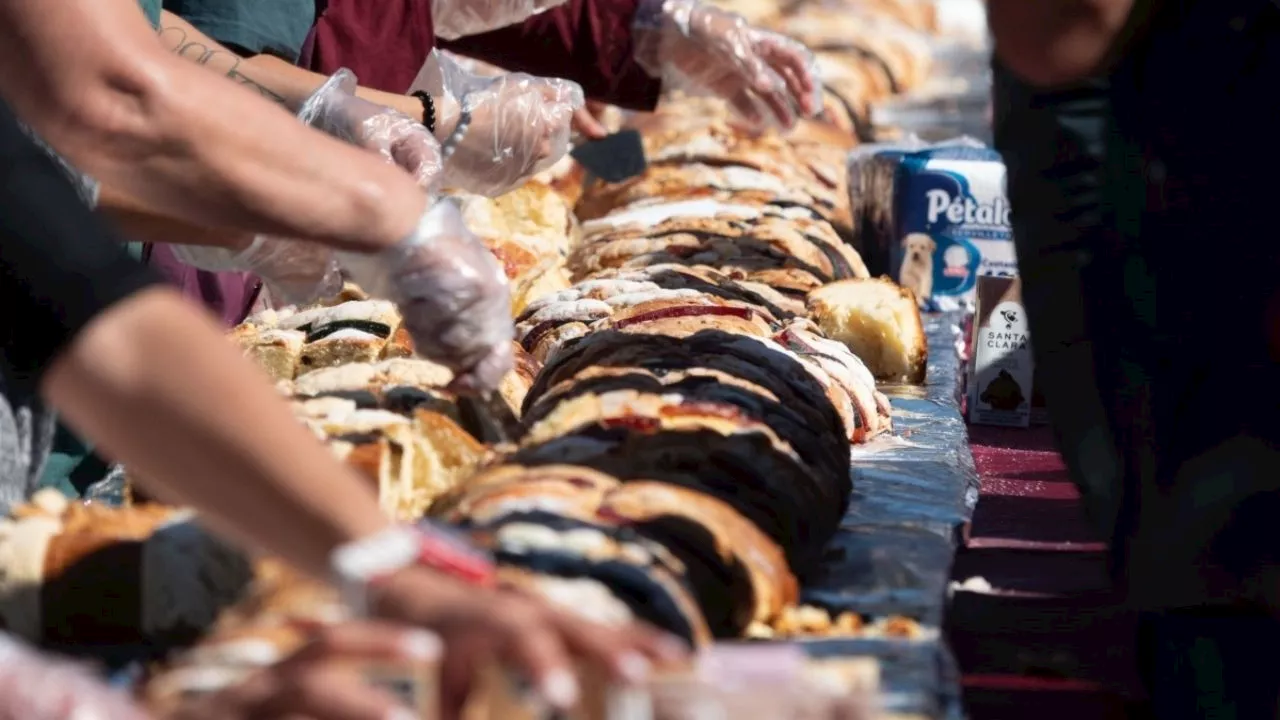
[159,10,422,120]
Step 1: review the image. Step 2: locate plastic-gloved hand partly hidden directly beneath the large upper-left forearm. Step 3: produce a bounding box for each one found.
[173,236,342,305]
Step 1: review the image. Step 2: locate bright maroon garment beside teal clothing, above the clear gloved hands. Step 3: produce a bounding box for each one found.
[300,0,435,94]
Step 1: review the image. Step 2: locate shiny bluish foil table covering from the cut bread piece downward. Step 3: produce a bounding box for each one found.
[801,313,978,717]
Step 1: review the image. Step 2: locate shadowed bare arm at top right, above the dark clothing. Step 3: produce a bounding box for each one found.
[987,0,1149,87]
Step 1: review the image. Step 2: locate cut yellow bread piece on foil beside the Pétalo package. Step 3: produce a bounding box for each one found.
[809,278,929,383]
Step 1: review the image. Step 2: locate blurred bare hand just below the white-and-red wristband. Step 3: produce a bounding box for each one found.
[378,568,687,720]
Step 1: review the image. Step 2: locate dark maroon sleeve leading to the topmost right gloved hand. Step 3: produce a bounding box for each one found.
[439,0,662,110]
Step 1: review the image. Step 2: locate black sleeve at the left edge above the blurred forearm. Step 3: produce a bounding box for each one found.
[0,102,160,387]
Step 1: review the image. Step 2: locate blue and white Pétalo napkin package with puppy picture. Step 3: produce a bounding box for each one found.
[890,147,1018,310]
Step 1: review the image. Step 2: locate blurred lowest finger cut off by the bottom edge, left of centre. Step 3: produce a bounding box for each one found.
[255,667,399,720]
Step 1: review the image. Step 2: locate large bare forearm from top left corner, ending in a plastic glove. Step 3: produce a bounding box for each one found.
[0,0,426,250]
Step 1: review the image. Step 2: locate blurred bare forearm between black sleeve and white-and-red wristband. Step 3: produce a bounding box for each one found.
[42,288,389,578]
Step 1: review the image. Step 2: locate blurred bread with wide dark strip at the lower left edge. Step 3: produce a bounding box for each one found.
[0,488,251,647]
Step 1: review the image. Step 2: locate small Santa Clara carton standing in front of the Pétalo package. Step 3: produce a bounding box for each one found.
[969,275,1036,428]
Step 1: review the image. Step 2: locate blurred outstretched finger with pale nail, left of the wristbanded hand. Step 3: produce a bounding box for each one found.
[287,621,440,664]
